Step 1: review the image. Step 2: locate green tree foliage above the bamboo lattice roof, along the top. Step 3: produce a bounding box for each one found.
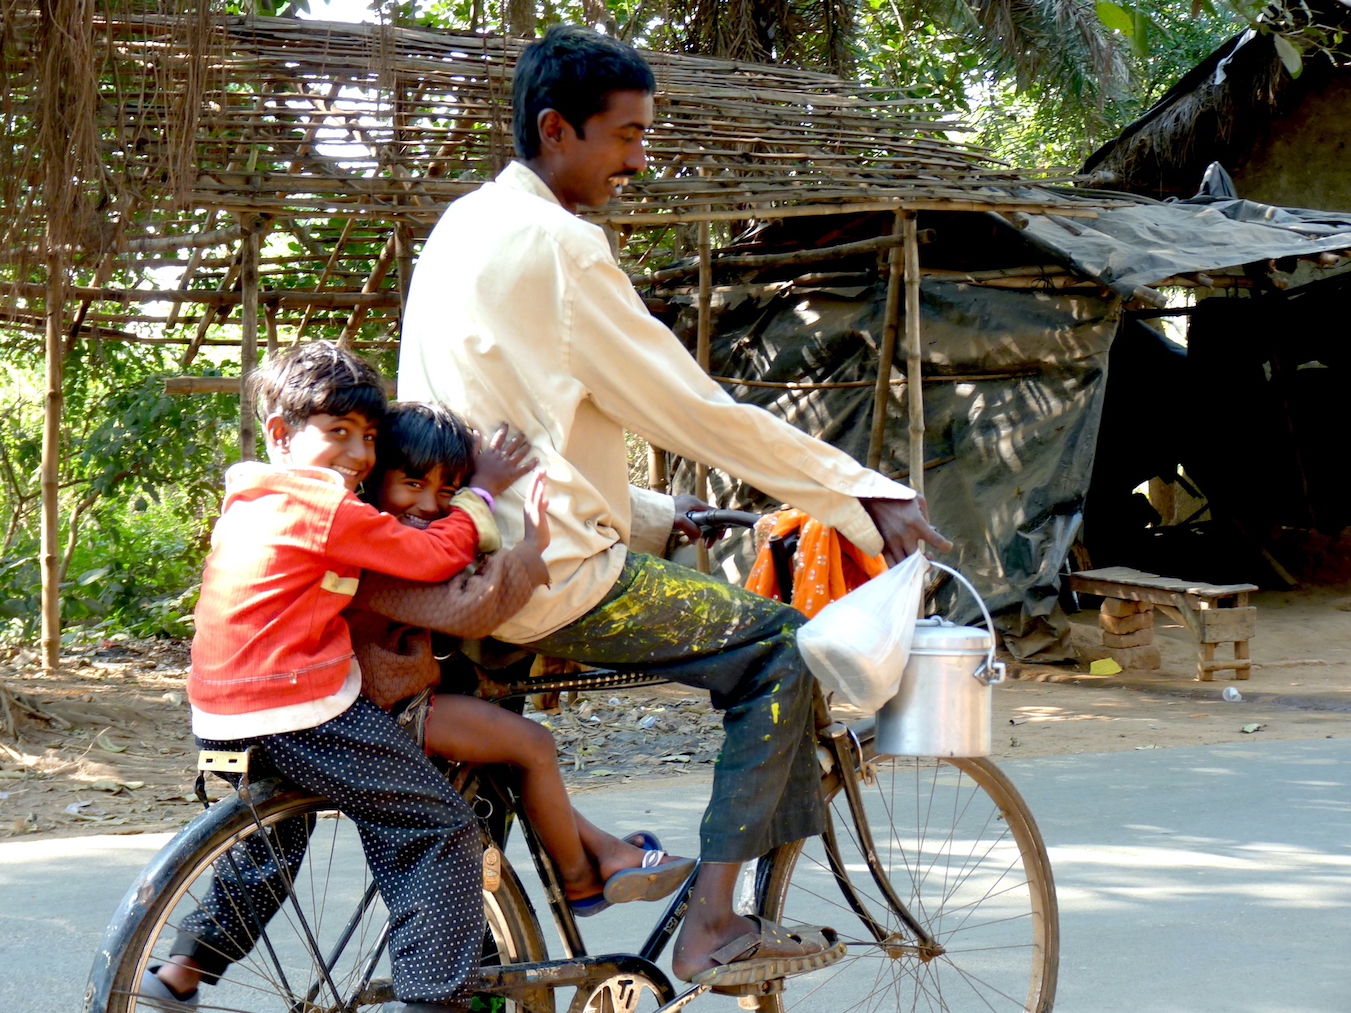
[372,0,1242,167]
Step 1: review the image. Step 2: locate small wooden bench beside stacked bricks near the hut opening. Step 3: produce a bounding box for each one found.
[1070,566,1258,682]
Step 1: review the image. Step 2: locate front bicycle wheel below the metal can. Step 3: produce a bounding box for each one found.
[757,732,1059,1013]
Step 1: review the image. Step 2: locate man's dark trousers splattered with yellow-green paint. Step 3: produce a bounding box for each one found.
[521,552,825,863]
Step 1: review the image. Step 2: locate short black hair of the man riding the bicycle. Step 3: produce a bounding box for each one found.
[511,24,657,158]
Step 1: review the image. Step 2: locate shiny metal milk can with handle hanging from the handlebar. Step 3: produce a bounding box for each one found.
[877,561,1004,756]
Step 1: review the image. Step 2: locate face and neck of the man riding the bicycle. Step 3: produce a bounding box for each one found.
[553,92,653,208]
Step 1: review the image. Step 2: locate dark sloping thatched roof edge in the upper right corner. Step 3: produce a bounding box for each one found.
[1082,0,1351,200]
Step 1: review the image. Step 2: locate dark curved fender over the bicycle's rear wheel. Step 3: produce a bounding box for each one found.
[84,778,296,1013]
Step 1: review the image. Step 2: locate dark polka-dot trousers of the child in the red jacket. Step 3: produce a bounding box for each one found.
[170,697,484,1002]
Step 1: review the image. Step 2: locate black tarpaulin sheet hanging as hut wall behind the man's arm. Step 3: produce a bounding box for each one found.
[673,278,1120,660]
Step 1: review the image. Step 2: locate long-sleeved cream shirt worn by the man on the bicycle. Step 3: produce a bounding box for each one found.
[399,162,915,643]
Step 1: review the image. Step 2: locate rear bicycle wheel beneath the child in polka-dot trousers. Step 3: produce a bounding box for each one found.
[85,779,547,1013]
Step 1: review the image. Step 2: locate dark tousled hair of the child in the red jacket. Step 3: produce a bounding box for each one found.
[253,342,388,425]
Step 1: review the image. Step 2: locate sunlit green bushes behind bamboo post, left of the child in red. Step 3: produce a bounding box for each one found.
[0,342,238,640]
